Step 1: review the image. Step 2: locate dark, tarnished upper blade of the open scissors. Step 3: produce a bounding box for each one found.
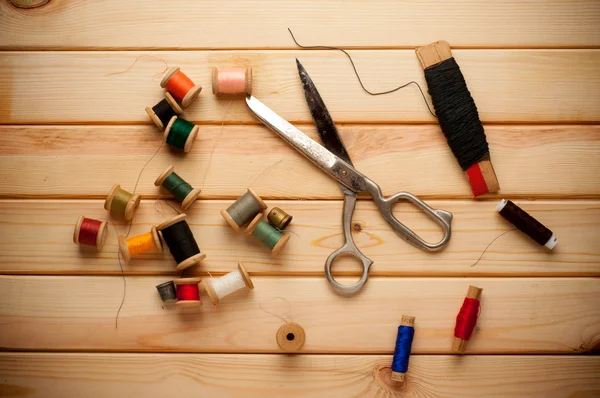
[296,58,353,166]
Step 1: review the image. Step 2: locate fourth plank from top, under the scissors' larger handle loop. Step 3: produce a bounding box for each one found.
[0,200,600,276]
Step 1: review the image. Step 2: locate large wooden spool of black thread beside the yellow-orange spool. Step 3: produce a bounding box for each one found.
[156,214,206,271]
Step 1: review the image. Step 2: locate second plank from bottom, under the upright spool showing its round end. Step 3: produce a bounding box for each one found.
[0,276,600,354]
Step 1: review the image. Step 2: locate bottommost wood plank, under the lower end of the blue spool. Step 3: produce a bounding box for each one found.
[0,353,600,398]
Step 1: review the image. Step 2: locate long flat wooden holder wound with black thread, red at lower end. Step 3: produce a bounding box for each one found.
[417,41,500,197]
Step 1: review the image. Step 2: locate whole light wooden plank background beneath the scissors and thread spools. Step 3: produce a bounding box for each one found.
[0,0,600,397]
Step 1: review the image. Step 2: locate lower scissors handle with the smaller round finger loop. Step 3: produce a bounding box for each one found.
[325,188,373,294]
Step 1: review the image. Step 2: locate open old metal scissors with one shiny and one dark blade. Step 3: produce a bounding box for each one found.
[246,59,452,293]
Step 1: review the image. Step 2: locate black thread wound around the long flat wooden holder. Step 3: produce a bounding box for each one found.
[425,58,490,171]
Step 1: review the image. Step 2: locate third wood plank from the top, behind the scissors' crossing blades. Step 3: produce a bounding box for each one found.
[0,125,600,199]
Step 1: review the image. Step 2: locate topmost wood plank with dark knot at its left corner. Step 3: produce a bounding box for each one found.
[0,0,600,50]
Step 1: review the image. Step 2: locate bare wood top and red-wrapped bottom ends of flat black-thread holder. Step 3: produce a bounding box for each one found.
[416,40,500,197]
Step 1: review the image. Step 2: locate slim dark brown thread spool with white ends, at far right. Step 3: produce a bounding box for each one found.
[496,199,558,250]
